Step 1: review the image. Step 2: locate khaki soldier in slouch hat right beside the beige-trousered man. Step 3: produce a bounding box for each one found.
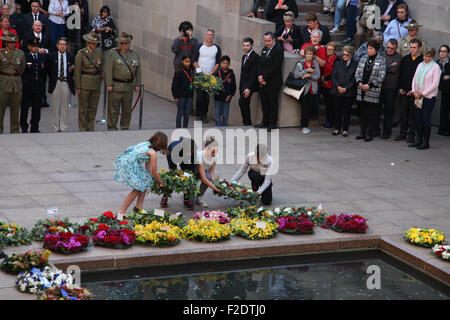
[74,32,103,131]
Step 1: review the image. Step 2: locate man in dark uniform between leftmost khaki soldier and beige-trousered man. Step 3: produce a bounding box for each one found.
[20,38,47,133]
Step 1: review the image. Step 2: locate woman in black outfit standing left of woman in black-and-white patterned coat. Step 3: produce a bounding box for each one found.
[330,46,358,137]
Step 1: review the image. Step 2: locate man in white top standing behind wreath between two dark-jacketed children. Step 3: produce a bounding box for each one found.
[192,30,222,123]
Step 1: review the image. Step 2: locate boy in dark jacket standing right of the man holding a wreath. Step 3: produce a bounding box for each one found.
[214,56,236,127]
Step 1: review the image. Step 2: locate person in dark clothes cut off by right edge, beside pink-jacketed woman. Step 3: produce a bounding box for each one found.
[436,44,450,136]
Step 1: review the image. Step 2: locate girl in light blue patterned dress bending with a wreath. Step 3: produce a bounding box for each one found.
[114,131,167,219]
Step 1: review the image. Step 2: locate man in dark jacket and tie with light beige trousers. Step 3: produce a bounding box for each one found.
[47,37,75,132]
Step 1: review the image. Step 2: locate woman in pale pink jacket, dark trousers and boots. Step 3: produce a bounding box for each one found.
[408,48,442,150]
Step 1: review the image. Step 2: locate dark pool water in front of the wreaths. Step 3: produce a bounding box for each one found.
[82,252,450,300]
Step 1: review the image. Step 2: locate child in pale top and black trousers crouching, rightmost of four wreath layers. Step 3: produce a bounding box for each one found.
[231,144,272,206]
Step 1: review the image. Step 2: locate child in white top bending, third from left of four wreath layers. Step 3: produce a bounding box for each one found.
[196,137,222,208]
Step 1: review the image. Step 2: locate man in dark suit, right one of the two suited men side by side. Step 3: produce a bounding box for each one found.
[256,32,284,131]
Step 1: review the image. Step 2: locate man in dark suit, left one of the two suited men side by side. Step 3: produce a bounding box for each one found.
[239,38,259,126]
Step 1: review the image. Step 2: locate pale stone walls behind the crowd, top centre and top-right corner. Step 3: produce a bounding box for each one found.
[89,0,450,125]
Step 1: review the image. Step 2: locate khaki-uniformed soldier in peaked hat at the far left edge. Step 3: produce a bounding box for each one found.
[0,32,25,133]
